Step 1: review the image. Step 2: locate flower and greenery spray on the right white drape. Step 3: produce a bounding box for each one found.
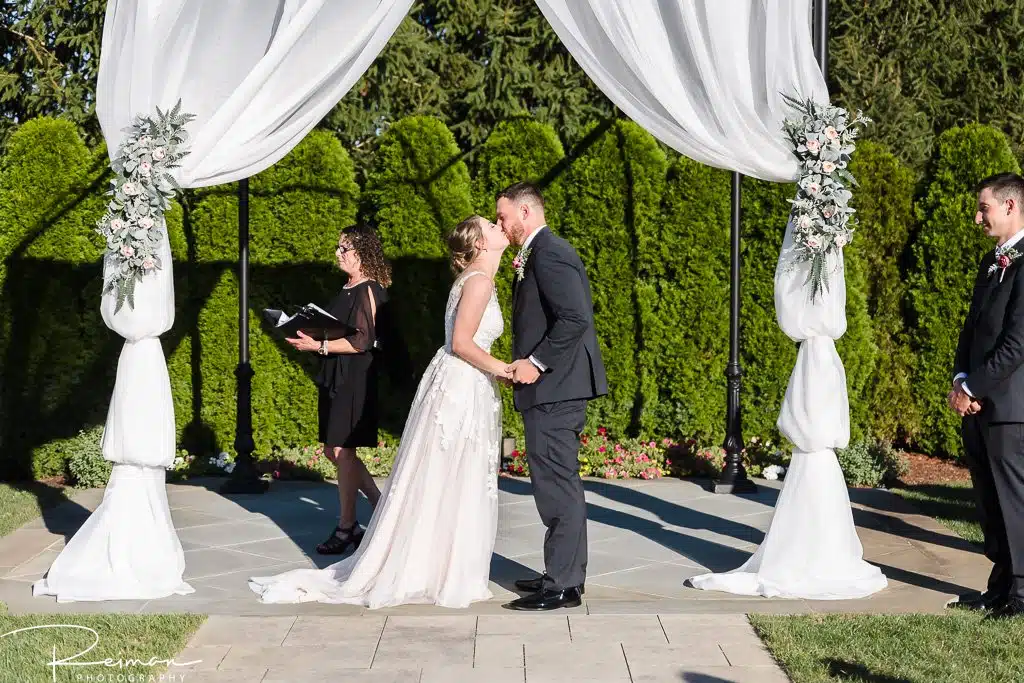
[783,95,871,301]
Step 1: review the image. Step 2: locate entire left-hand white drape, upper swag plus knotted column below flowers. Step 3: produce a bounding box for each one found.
[34,0,412,601]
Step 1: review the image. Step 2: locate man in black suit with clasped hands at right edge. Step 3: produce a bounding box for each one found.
[947,173,1024,617]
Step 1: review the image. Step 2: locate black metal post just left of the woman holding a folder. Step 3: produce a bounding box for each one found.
[220,178,270,494]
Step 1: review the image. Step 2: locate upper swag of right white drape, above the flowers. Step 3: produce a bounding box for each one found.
[537,0,828,181]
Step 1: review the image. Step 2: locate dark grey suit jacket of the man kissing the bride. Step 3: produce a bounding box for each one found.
[512,227,608,411]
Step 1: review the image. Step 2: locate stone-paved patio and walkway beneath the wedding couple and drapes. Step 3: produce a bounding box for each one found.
[0,478,988,683]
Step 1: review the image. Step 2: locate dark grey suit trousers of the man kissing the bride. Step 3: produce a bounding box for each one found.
[522,399,587,590]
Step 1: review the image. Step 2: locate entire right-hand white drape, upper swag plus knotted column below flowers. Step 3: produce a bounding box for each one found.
[537,0,886,598]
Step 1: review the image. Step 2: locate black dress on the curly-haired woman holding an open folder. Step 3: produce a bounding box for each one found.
[315,280,387,449]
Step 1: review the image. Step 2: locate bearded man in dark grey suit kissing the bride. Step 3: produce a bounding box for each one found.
[497,182,608,610]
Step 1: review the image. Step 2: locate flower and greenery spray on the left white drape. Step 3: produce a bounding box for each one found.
[96,100,196,312]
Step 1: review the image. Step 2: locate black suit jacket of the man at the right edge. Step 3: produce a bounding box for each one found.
[953,246,1024,413]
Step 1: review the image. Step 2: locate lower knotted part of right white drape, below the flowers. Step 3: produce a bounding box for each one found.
[690,224,888,600]
